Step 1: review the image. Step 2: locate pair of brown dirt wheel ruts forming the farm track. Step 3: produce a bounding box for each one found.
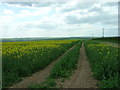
[11,43,97,88]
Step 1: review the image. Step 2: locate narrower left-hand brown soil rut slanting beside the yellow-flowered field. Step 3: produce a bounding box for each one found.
[10,45,75,88]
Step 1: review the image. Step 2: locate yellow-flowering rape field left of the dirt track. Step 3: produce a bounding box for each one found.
[2,40,78,87]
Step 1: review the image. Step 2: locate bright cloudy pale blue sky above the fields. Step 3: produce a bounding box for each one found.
[0,0,118,38]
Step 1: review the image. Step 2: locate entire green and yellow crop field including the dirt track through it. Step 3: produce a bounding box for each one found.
[2,39,120,88]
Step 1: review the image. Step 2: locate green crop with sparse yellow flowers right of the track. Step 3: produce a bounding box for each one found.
[85,40,120,88]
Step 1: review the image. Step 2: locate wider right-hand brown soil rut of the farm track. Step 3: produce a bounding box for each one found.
[63,43,97,88]
